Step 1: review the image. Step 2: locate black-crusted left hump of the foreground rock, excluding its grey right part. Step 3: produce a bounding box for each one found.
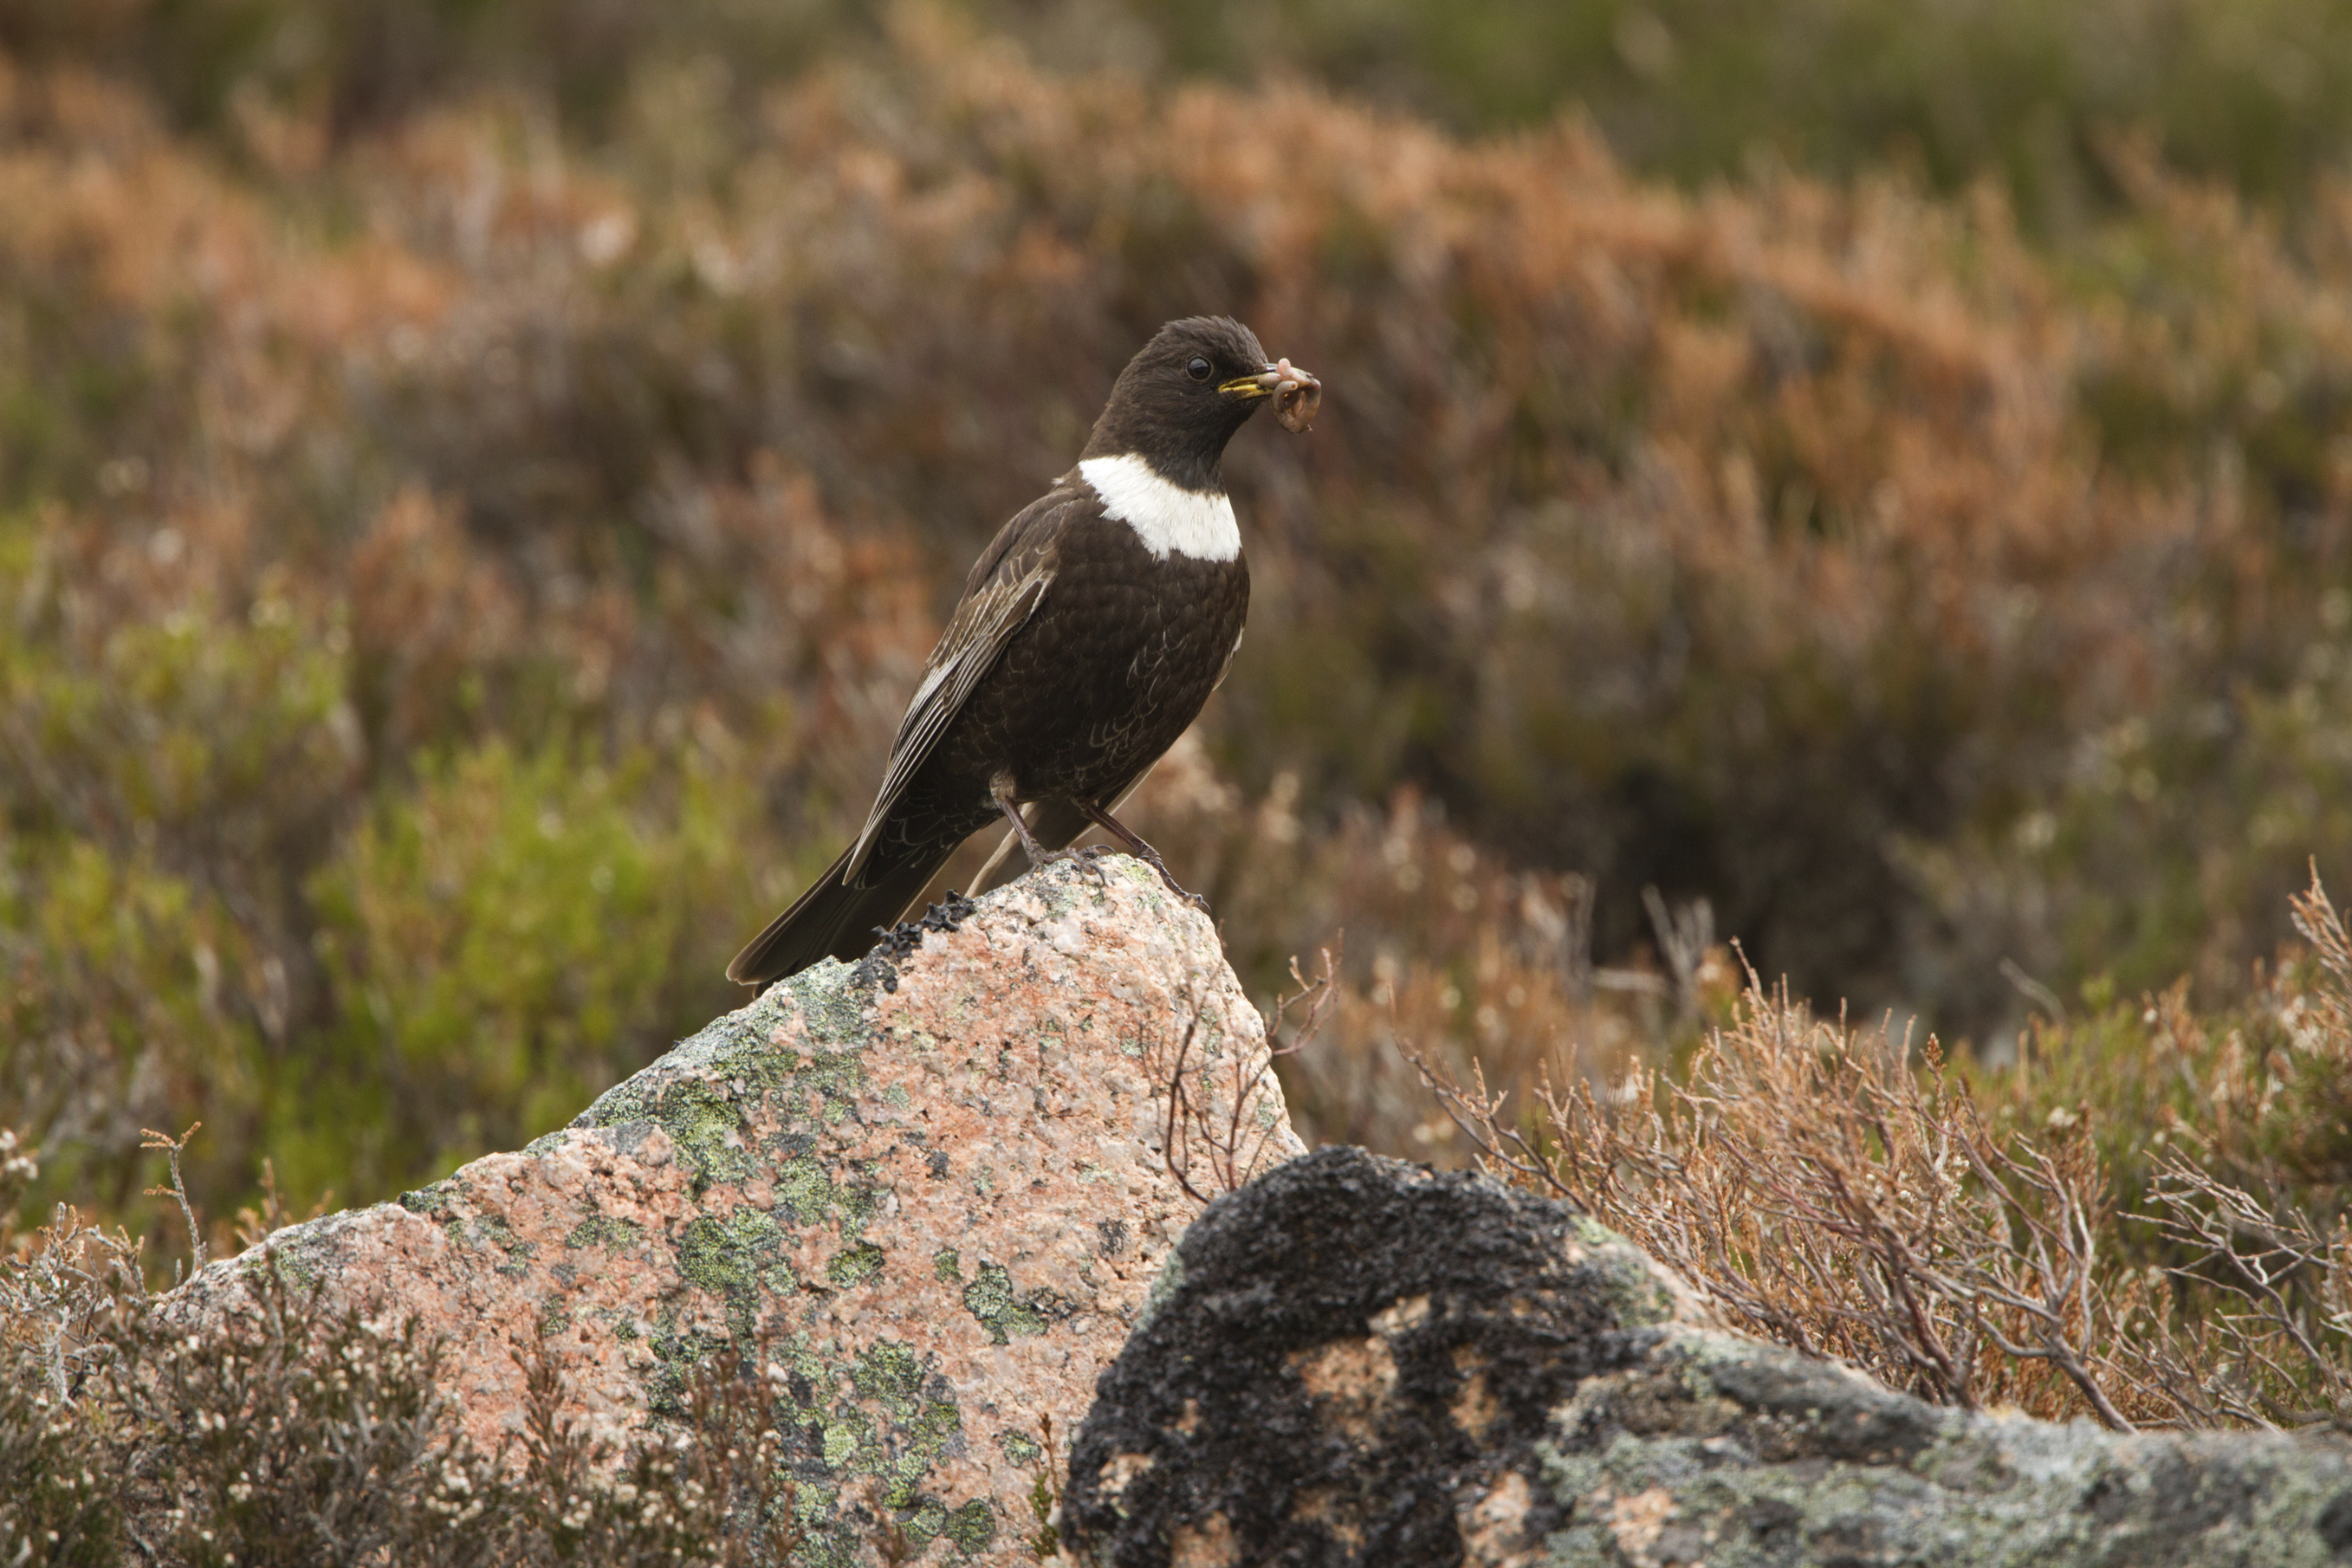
[1063,1147,1675,1565]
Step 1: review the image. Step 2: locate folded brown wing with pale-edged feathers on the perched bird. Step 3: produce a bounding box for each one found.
[842,487,1085,882]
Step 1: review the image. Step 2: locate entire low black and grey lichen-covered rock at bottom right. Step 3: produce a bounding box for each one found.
[1063,1150,2352,1568]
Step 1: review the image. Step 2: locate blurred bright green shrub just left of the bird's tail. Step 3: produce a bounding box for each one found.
[298,741,743,1192]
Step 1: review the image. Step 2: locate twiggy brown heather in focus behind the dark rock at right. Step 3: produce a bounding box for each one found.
[1416,870,2352,1429]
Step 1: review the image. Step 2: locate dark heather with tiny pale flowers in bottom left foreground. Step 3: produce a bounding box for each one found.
[0,1189,813,1568]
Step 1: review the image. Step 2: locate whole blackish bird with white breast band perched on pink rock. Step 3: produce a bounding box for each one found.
[727,317,1322,985]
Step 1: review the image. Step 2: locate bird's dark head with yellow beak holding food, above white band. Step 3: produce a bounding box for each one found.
[1082,315,1322,489]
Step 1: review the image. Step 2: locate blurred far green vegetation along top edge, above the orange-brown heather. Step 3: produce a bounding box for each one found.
[13,0,2352,221]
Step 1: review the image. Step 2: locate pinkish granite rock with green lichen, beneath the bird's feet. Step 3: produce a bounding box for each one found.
[165,858,1300,1564]
